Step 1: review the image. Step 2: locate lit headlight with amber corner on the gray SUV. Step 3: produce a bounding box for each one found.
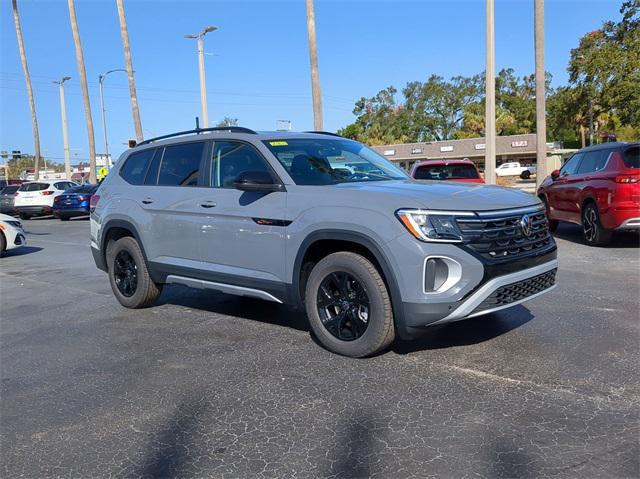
[396,210,475,243]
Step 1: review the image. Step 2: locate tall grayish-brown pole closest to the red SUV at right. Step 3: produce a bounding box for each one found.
[534,0,547,186]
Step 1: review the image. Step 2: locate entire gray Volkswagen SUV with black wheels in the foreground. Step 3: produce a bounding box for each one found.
[91,127,558,357]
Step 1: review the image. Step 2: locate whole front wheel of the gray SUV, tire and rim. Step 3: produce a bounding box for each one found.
[305,251,395,358]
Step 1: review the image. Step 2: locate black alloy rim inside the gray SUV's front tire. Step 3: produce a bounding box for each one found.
[316,271,370,341]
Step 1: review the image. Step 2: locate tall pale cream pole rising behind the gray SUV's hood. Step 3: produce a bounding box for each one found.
[484,0,496,185]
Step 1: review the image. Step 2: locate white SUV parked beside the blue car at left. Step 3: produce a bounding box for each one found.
[13,180,78,220]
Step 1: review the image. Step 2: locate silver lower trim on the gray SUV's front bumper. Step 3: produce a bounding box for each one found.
[432,259,558,324]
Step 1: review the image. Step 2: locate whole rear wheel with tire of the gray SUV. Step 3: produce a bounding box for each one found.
[107,236,162,309]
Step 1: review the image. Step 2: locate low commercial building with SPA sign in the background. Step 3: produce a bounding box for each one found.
[373,134,575,171]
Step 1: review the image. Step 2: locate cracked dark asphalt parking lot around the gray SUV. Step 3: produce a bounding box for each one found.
[0,219,640,478]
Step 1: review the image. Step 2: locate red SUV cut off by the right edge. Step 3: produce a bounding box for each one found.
[538,143,640,246]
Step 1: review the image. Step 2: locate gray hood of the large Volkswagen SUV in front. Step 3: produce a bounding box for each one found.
[337,180,540,211]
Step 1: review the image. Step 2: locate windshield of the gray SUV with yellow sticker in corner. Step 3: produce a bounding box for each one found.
[264,138,407,185]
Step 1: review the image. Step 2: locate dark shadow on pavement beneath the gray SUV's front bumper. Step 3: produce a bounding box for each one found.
[393,305,534,354]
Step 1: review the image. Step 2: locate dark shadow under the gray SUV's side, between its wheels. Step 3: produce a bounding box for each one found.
[158,285,310,332]
